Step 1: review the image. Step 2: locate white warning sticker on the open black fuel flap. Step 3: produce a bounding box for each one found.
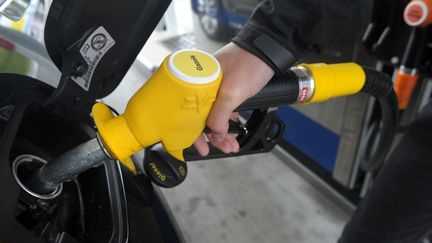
[72,26,115,91]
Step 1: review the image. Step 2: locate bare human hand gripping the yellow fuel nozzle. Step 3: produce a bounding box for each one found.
[194,43,274,156]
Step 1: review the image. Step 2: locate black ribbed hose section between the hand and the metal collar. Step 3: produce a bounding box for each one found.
[236,70,299,111]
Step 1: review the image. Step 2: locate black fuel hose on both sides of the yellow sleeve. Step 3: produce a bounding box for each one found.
[236,67,398,172]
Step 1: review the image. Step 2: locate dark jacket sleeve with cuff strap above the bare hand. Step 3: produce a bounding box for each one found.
[233,0,353,71]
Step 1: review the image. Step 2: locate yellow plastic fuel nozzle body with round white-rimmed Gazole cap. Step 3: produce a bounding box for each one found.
[92,50,222,172]
